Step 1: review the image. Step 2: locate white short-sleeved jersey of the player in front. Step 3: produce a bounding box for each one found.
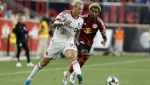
[52,10,83,42]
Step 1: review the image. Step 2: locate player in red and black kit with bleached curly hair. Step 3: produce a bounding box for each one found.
[63,3,107,85]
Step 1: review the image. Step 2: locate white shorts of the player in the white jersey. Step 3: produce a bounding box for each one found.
[44,41,77,59]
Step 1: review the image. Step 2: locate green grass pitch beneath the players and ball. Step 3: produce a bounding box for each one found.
[0,55,150,85]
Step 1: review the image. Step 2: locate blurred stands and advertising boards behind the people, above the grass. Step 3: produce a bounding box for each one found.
[0,0,150,56]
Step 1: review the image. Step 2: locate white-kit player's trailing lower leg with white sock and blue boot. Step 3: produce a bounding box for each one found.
[24,57,51,85]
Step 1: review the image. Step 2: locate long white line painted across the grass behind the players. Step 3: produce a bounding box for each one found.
[0,58,150,76]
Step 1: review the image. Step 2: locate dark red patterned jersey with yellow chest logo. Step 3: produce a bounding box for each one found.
[78,14,105,46]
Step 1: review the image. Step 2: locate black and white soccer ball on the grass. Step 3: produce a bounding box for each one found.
[106,76,119,85]
